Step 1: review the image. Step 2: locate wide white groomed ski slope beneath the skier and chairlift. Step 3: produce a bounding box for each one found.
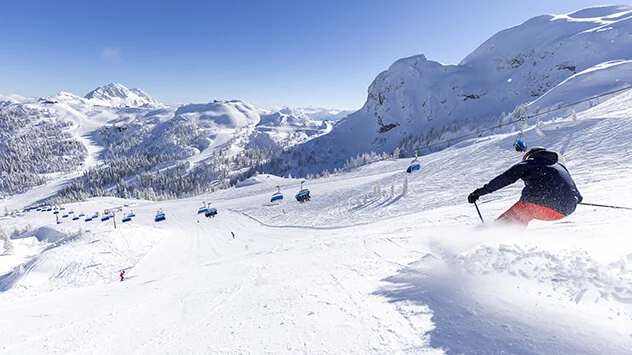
[0,92,632,354]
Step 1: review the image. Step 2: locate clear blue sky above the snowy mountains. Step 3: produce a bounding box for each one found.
[0,0,612,109]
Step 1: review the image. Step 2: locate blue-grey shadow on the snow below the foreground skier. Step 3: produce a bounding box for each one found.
[374,267,599,354]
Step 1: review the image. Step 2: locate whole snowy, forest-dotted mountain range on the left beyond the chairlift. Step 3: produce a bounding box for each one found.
[0,84,331,198]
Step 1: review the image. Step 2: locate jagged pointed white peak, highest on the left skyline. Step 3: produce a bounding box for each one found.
[84,83,163,107]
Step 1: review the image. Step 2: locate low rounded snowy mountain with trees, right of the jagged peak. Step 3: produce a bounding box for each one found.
[140,100,331,161]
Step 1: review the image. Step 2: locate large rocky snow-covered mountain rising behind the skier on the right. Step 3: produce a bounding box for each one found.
[290,5,632,171]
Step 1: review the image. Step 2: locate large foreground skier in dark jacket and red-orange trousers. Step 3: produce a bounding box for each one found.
[467,147,582,227]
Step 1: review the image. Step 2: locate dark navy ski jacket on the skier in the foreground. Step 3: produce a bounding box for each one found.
[476,150,582,216]
